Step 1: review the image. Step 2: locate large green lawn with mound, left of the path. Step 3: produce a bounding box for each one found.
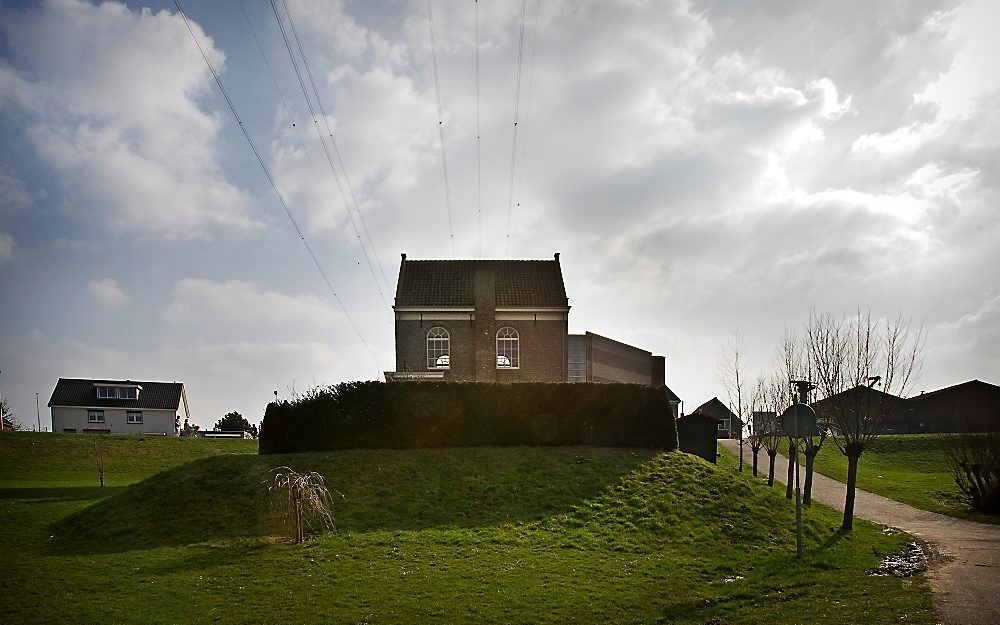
[0,433,936,625]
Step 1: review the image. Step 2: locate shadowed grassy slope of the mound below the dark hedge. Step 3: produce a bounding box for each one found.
[52,447,655,551]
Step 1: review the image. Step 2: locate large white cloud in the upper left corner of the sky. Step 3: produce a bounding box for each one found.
[0,0,257,238]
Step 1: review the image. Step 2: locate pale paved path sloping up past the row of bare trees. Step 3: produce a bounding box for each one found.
[723,440,1000,625]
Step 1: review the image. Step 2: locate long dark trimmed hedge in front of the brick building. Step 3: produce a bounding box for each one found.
[260,382,677,454]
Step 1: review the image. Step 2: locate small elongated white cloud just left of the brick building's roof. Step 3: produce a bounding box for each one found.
[163,278,342,327]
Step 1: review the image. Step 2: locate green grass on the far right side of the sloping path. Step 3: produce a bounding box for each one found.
[776,434,1000,523]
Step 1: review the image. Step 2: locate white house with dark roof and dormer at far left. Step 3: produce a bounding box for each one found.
[49,378,191,436]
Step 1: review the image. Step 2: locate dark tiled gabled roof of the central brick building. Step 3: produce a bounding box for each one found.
[395,254,569,308]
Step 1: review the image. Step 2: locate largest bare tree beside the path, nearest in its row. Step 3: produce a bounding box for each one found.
[806,312,926,530]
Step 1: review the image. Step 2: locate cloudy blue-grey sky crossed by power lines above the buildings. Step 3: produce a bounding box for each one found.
[0,0,1000,428]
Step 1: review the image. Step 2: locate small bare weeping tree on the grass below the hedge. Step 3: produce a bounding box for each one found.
[265,466,337,544]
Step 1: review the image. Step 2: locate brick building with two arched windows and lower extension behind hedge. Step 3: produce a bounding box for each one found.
[386,254,680,398]
